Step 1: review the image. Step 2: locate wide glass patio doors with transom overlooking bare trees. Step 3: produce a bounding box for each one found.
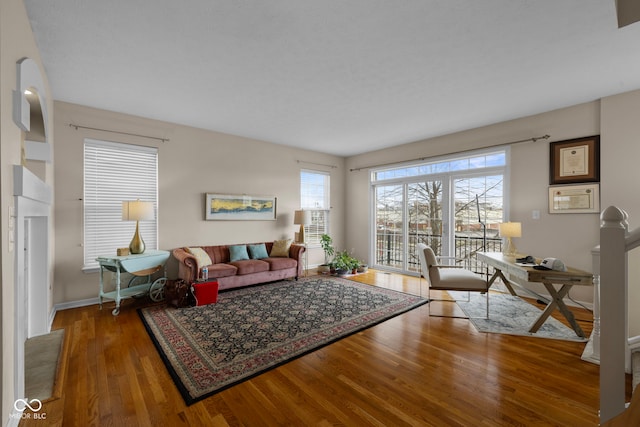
[371,149,507,273]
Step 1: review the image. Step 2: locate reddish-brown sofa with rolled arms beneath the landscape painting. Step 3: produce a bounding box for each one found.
[173,242,305,290]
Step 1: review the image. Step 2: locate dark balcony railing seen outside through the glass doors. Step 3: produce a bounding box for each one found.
[375,231,502,274]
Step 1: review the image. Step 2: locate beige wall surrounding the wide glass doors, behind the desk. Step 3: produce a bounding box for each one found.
[346,102,606,302]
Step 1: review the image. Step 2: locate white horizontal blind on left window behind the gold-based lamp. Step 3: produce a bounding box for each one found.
[83,139,158,269]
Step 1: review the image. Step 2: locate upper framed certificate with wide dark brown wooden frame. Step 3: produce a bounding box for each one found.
[549,135,600,185]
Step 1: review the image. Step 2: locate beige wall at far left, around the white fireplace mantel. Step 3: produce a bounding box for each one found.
[0,0,53,424]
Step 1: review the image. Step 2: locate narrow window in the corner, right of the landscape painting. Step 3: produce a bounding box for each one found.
[300,170,329,246]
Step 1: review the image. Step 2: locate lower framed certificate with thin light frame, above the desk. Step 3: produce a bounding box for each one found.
[549,184,600,213]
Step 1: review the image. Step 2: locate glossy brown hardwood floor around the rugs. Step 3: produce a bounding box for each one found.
[21,271,631,426]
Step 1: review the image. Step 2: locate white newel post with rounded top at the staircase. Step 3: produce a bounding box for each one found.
[600,206,628,423]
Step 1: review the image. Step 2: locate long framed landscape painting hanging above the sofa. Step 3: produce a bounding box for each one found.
[205,193,276,221]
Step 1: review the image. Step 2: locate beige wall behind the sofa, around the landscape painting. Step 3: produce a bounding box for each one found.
[54,102,345,303]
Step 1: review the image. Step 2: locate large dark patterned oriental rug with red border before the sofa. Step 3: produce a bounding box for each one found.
[138,276,427,405]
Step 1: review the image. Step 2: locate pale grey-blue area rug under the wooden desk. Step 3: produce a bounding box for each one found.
[447,291,588,342]
